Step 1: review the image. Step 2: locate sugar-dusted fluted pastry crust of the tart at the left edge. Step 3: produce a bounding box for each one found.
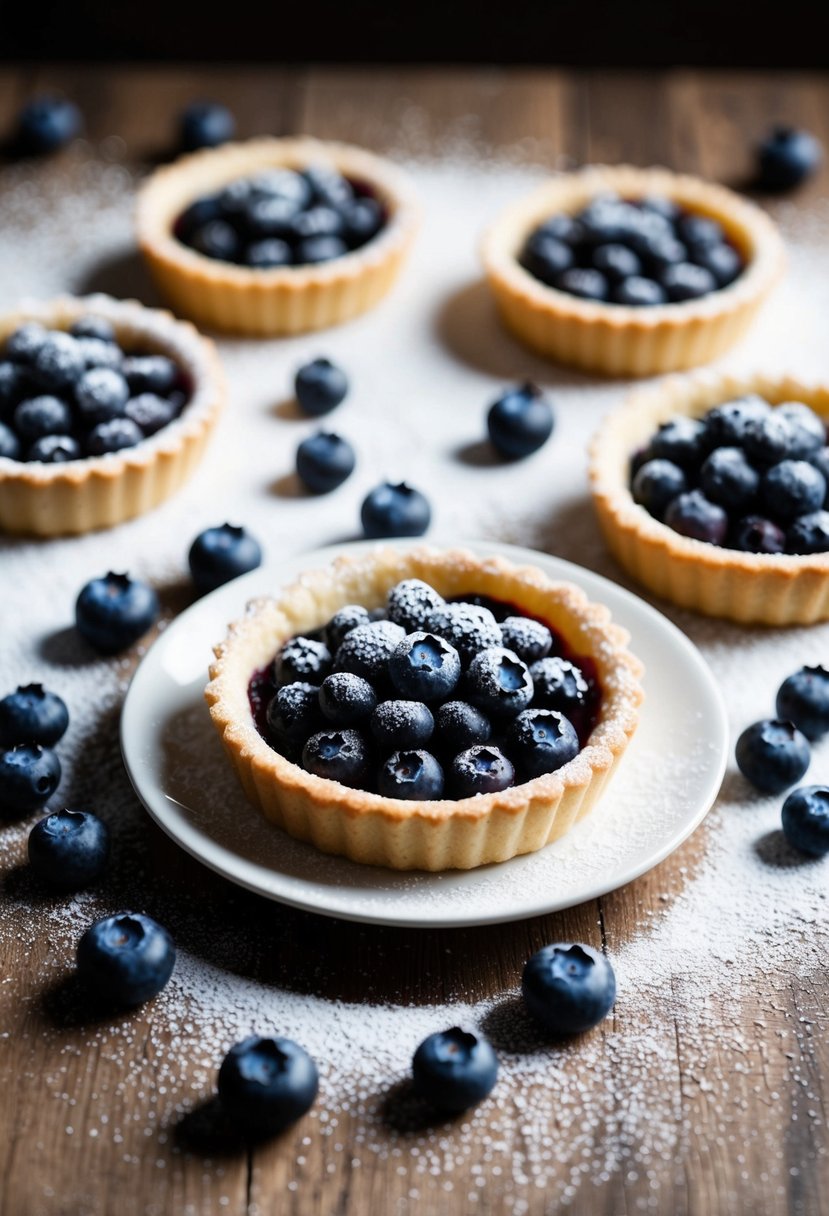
[0,295,225,536]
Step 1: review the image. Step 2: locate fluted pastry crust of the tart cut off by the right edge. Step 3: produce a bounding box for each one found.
[590,372,829,625]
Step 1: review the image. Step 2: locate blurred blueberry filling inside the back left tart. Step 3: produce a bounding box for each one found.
[173,165,389,270]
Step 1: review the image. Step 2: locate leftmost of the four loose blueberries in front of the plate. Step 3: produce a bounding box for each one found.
[78,912,175,1006]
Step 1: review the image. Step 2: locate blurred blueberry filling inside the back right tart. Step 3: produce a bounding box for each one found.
[518,195,745,308]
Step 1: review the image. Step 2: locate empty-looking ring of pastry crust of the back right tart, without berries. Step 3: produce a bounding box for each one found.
[481,165,784,376]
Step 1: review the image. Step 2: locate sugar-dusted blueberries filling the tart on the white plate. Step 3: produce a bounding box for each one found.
[250,579,600,800]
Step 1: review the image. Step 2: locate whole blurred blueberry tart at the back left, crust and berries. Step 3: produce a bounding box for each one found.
[137,139,417,336]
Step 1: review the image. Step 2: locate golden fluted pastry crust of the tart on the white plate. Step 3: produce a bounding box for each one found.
[205,546,642,871]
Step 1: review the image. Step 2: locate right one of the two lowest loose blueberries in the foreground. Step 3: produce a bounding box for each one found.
[412,1026,498,1115]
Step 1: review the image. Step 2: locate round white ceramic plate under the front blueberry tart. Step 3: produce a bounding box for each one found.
[122,542,728,928]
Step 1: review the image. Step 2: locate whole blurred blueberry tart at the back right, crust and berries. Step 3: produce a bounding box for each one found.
[481,165,784,376]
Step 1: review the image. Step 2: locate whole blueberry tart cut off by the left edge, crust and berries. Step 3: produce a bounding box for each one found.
[0,295,225,536]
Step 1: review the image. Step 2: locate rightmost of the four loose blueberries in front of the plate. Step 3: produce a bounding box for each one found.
[521,941,616,1035]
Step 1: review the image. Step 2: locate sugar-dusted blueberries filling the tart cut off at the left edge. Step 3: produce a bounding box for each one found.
[0,316,190,465]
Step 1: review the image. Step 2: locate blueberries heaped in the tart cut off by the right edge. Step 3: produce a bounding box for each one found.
[631,394,829,553]
